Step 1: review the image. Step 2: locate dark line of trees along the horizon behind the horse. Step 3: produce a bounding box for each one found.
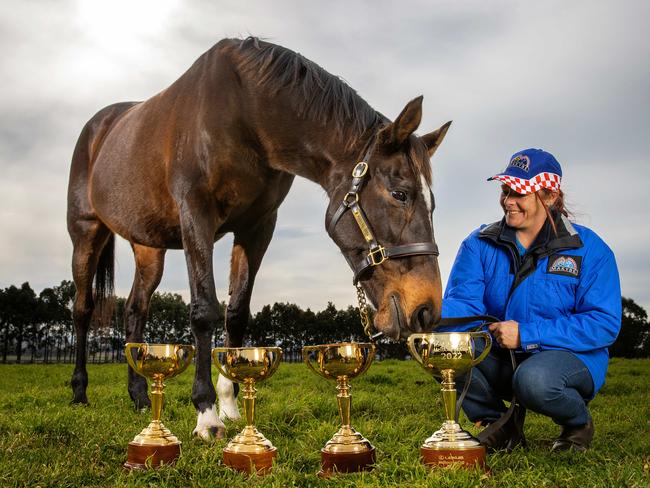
[0,280,650,363]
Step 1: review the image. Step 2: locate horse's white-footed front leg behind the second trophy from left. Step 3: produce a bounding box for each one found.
[217,211,277,420]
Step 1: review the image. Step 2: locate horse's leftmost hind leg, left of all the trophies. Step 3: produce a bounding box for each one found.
[70,218,113,404]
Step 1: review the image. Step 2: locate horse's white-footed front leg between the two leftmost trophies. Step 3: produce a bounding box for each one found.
[181,202,225,440]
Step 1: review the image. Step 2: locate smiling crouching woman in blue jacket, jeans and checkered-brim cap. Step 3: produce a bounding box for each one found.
[442,149,621,451]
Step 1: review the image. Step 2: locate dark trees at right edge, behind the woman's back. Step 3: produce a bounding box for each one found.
[609,297,650,358]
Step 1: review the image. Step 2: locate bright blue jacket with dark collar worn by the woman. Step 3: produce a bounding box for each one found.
[442,215,621,395]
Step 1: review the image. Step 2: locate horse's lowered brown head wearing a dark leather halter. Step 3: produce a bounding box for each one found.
[326,97,451,339]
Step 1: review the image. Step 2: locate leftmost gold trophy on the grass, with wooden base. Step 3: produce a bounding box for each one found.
[124,342,194,469]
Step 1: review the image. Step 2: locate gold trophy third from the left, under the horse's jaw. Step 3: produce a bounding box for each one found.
[302,342,376,477]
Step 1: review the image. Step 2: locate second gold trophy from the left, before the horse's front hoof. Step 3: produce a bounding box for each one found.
[212,347,282,474]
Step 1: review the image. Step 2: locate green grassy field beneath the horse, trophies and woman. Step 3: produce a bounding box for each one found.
[0,360,650,488]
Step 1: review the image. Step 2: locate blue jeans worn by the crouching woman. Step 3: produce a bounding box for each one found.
[456,347,594,426]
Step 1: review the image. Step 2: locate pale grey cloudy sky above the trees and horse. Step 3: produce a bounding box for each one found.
[0,0,650,311]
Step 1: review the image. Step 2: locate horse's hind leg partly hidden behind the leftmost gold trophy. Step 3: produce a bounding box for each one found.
[124,244,165,410]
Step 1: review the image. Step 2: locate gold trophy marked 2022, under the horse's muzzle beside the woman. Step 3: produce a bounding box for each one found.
[408,332,492,469]
